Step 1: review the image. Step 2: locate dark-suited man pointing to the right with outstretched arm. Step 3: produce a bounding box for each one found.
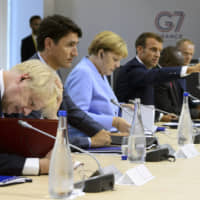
[116,32,200,121]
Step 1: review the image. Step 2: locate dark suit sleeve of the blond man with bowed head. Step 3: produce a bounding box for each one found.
[0,92,25,175]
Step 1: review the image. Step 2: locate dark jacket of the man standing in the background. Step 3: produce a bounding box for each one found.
[21,35,36,62]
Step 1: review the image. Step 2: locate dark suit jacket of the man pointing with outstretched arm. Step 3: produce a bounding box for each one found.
[116,58,181,105]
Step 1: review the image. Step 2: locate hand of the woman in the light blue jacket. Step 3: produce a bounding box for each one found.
[112,117,131,133]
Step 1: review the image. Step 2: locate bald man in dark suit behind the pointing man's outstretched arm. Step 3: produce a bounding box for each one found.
[155,46,200,119]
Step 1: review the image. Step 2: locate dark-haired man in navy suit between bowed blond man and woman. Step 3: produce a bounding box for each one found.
[27,15,127,147]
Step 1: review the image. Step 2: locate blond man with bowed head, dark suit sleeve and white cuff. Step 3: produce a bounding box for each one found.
[0,60,62,175]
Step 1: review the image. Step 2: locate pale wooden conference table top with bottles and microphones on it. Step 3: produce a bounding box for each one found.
[0,126,200,200]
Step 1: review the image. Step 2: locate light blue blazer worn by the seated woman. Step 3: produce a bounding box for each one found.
[64,62,115,130]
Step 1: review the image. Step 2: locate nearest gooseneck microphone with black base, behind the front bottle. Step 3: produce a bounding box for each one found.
[18,120,114,192]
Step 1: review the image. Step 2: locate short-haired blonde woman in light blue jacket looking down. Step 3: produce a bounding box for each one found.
[65,31,130,138]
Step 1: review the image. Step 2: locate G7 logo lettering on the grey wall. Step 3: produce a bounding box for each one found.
[155,11,185,32]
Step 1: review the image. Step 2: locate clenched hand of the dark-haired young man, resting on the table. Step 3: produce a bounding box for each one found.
[91,130,111,147]
